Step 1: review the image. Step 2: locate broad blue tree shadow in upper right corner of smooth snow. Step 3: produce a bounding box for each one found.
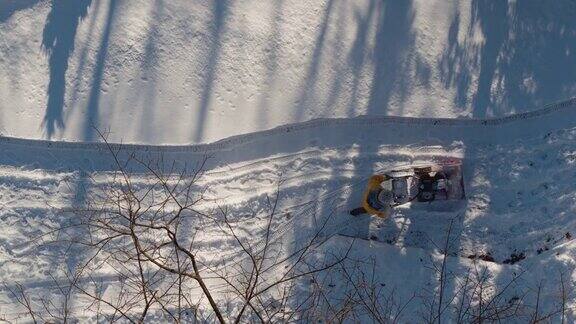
[438,1,576,118]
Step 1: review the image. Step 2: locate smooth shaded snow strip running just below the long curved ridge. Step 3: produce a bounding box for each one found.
[0,98,576,171]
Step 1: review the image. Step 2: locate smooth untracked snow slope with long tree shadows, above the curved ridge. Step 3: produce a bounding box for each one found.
[0,0,576,144]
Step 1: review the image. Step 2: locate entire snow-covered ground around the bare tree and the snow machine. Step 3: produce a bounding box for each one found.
[0,0,576,323]
